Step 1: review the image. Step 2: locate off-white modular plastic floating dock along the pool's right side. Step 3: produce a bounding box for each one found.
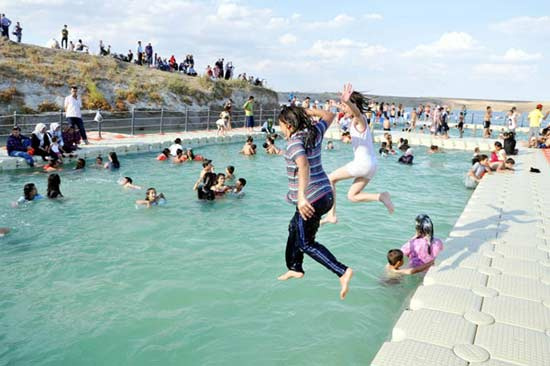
[372,150,550,366]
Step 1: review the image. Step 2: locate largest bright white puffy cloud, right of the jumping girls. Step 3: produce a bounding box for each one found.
[403,32,480,57]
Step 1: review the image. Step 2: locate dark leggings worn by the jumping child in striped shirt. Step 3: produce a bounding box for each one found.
[285,193,348,277]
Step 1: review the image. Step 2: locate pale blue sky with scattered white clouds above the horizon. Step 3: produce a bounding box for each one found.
[0,0,550,100]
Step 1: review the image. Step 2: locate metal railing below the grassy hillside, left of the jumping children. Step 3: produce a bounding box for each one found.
[0,106,279,144]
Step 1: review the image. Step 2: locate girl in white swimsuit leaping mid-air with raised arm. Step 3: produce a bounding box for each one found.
[321,84,394,224]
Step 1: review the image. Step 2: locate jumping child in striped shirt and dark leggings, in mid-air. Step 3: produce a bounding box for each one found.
[278,106,353,300]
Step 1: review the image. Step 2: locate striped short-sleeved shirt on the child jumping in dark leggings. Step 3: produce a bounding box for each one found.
[285,120,332,204]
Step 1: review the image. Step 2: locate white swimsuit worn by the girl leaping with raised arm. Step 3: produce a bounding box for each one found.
[346,117,378,180]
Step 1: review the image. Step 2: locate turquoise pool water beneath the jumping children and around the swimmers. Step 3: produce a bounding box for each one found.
[0,144,471,365]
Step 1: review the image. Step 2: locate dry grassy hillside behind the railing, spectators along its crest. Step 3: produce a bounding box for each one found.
[0,39,277,112]
